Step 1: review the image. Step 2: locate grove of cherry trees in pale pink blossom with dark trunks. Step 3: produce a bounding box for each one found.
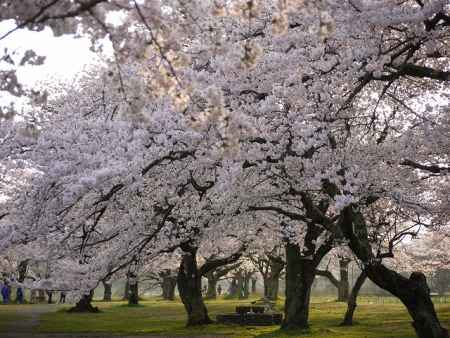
[0,0,450,338]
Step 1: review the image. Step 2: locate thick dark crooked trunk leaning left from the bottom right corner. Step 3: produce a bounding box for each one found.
[339,205,449,338]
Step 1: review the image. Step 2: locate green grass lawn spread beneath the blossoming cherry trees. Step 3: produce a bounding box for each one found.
[4,297,450,338]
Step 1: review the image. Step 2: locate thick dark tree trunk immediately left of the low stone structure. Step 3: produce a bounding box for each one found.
[177,248,212,326]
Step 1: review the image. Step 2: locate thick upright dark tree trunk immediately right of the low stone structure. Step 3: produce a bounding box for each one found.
[281,243,317,330]
